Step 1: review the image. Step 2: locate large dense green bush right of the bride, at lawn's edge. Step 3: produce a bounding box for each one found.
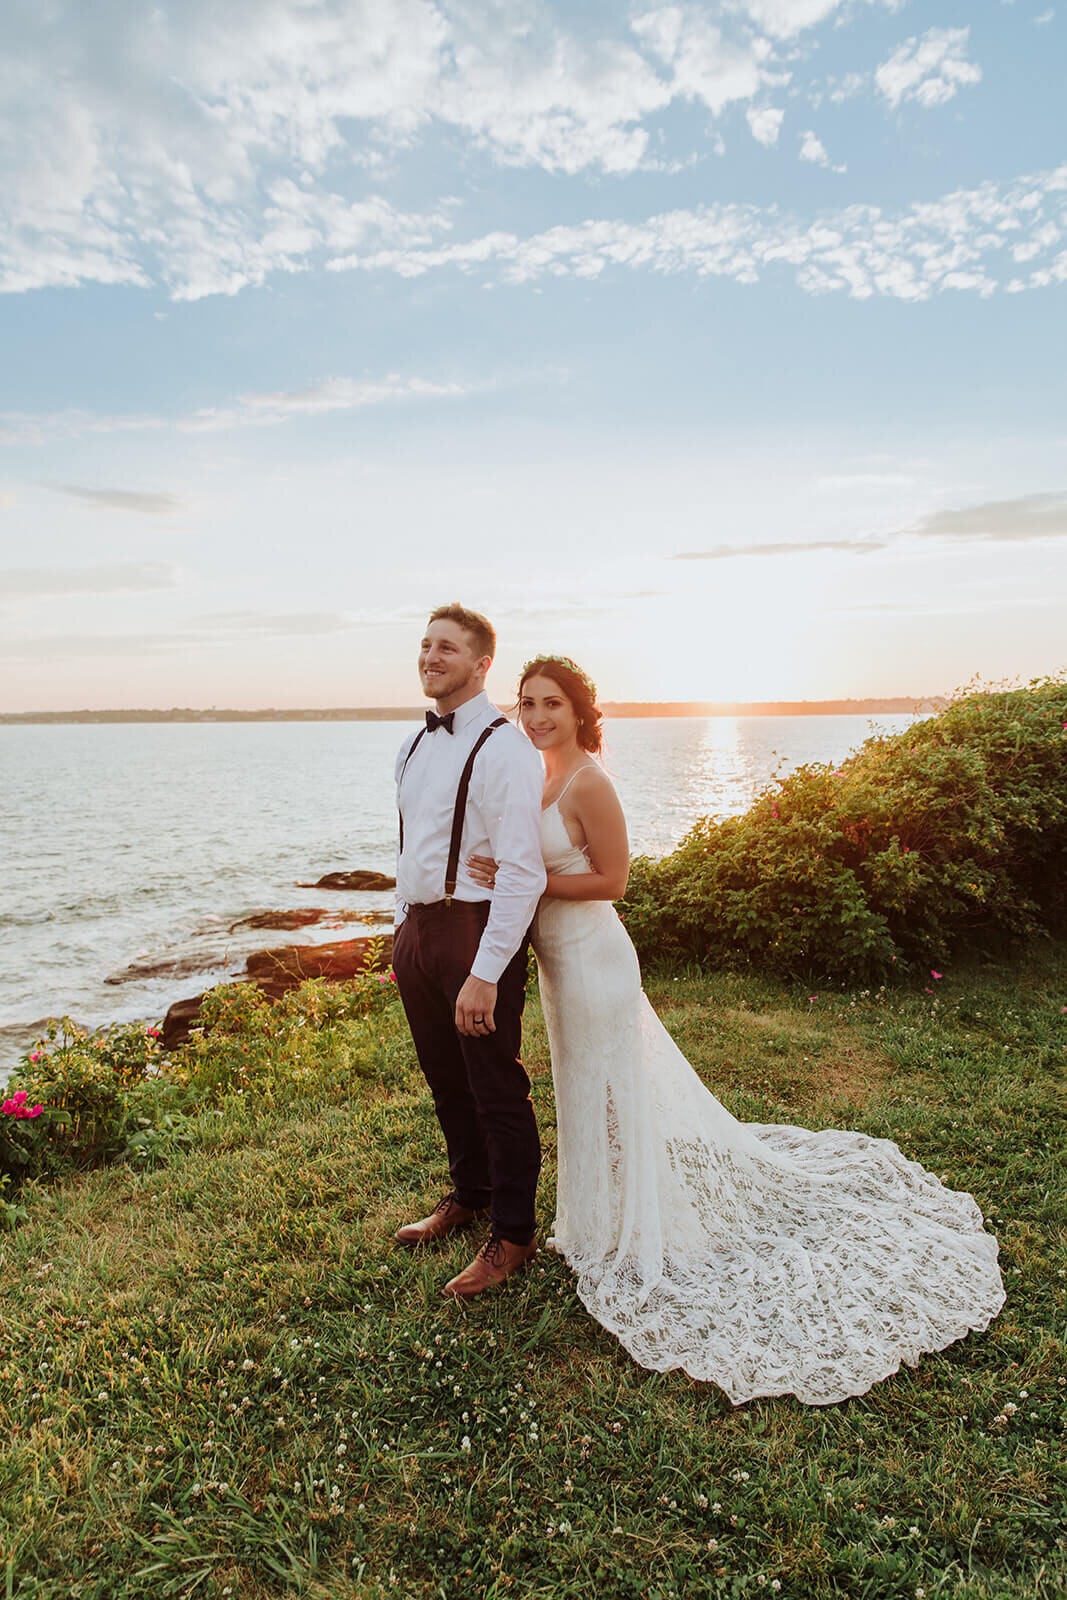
[619,678,1067,982]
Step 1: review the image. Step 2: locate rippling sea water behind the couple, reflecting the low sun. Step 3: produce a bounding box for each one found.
[0,717,912,1069]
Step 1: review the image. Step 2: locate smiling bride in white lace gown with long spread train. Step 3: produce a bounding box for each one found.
[470,656,1005,1405]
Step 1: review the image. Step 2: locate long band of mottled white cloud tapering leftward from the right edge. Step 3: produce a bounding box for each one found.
[326,165,1067,301]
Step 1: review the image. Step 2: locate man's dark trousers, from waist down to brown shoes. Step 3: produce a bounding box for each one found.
[392,899,541,1245]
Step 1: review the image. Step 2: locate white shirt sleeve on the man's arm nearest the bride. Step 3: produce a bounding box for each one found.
[470,728,547,984]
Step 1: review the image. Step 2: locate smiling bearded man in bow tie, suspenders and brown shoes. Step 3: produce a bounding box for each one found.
[394,605,545,1299]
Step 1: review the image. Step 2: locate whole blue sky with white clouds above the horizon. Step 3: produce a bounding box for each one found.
[0,0,1067,710]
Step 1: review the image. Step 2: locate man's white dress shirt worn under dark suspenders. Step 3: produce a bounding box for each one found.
[397,693,545,984]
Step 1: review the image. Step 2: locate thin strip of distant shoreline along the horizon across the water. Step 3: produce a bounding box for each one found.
[0,694,947,726]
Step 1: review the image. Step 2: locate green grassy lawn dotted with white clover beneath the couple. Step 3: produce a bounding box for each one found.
[0,946,1067,1600]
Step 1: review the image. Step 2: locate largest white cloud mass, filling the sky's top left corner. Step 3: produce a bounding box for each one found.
[0,0,921,299]
